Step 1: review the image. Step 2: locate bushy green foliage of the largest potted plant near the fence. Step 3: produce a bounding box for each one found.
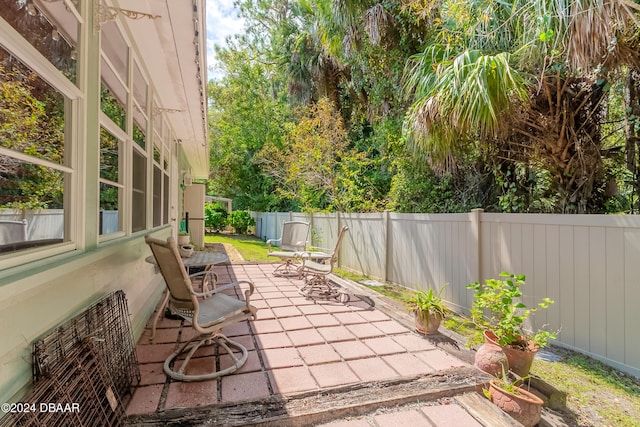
[467,272,556,349]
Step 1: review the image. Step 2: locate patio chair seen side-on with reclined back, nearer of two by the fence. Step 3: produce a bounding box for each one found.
[299,225,349,302]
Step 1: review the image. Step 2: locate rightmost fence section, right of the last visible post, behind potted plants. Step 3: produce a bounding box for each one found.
[481,213,640,376]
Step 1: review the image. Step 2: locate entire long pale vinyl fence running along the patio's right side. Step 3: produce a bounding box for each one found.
[253,210,640,377]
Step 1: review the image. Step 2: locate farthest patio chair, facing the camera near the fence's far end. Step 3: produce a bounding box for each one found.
[267,221,309,277]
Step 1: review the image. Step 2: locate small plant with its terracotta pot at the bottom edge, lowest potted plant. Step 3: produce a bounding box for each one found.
[484,370,544,427]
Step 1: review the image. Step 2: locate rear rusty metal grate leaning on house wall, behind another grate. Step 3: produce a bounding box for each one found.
[33,290,140,404]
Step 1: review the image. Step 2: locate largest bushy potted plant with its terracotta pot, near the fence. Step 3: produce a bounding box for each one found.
[467,272,556,377]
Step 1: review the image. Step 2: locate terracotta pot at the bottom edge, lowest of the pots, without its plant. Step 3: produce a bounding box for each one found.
[489,380,543,427]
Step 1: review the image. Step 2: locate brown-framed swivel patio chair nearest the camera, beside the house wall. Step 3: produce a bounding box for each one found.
[145,236,257,381]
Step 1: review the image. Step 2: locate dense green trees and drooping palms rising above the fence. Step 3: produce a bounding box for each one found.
[209,0,640,213]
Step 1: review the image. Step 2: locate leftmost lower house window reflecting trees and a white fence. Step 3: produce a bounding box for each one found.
[0,45,73,257]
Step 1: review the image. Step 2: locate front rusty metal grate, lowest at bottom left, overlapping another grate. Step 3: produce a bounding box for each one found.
[0,338,125,427]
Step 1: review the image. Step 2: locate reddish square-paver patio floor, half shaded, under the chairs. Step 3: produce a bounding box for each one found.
[127,264,492,427]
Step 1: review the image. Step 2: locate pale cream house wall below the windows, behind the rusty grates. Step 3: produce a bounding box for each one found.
[0,232,168,402]
